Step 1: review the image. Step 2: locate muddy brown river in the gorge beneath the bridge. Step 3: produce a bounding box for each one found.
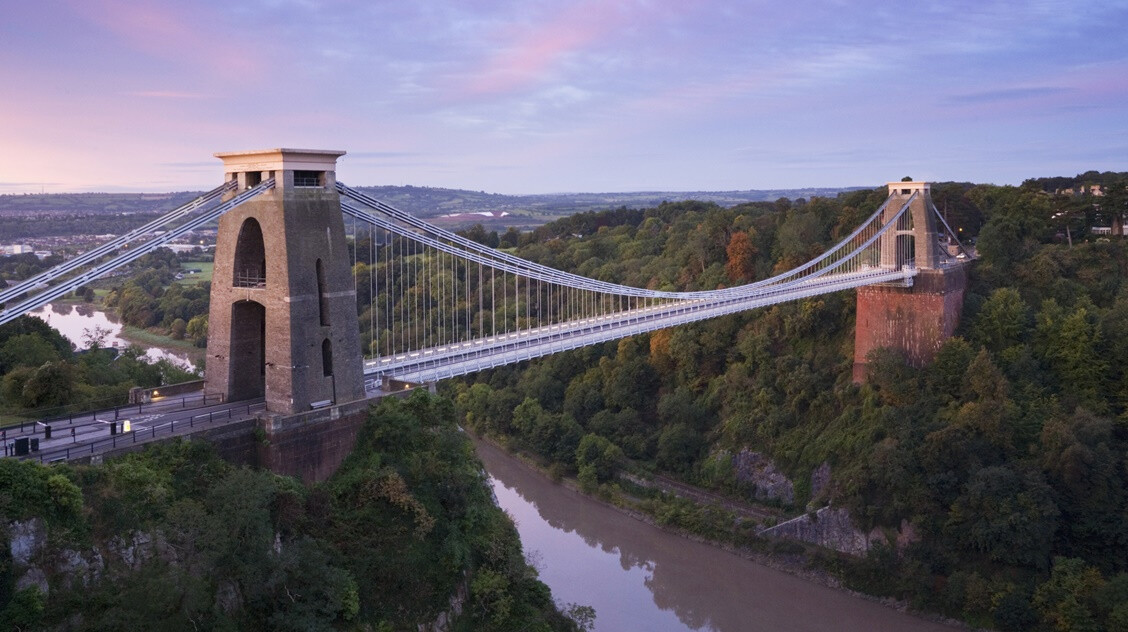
[477,442,958,632]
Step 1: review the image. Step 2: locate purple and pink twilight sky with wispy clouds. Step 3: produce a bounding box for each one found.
[0,0,1128,194]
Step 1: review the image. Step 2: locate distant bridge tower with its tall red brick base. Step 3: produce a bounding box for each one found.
[854,182,968,383]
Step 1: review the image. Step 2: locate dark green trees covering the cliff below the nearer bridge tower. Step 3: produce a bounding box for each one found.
[0,393,579,632]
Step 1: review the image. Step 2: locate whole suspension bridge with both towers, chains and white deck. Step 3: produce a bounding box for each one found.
[0,149,970,414]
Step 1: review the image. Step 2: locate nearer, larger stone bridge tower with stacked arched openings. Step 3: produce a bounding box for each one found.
[205,149,364,414]
